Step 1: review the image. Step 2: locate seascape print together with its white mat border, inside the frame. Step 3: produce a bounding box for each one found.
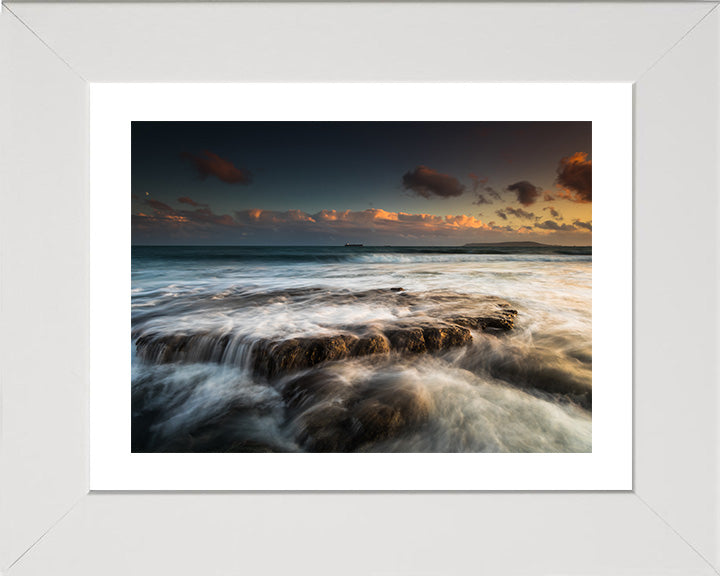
[90,84,632,490]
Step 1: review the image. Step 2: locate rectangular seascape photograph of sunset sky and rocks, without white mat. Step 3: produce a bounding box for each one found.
[130,121,592,453]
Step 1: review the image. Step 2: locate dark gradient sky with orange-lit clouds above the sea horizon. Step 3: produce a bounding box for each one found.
[132,122,592,246]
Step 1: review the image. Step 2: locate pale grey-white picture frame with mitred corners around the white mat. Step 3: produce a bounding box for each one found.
[0,2,720,576]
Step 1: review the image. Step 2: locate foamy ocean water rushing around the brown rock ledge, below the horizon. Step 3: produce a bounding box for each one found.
[131,247,592,452]
